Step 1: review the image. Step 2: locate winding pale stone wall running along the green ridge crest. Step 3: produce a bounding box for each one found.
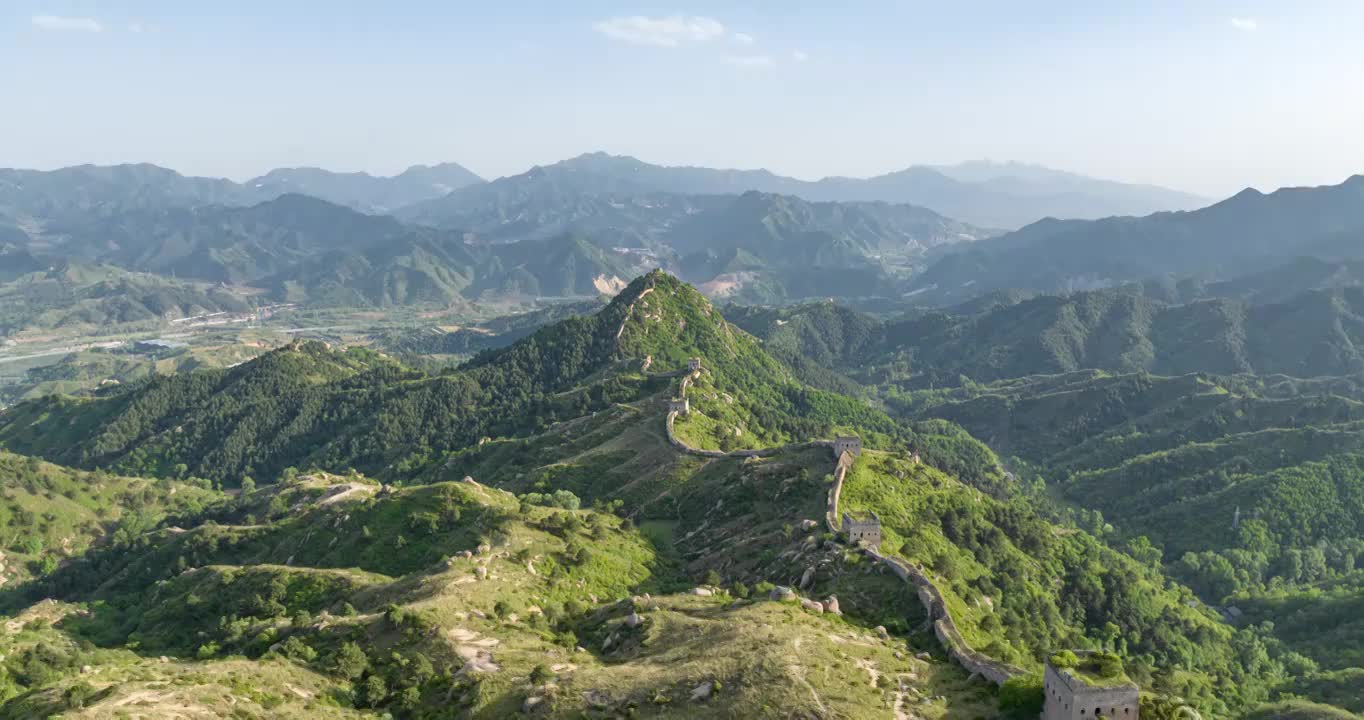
[657,364,1027,685]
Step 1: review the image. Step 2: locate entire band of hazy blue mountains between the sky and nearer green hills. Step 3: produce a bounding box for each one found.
[0,153,1364,319]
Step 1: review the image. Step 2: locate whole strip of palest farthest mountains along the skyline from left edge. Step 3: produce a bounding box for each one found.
[0,153,1206,235]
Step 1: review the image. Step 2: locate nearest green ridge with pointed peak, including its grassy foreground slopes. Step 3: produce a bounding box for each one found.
[0,273,1311,717]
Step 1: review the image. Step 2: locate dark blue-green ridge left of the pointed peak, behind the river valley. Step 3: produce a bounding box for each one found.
[19,194,638,307]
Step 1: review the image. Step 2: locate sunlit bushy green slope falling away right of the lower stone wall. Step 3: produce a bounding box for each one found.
[842,451,1262,712]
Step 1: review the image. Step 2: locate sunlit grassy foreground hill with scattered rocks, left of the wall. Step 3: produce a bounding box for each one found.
[0,455,994,717]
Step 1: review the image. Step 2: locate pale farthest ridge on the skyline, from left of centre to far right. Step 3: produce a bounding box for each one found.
[402,153,1207,228]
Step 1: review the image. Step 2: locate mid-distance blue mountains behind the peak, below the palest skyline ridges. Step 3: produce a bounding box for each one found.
[5,183,986,307]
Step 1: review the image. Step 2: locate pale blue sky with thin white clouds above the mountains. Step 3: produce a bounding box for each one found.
[0,0,1364,196]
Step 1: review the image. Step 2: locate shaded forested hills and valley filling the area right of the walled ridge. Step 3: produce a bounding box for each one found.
[731,283,1364,712]
